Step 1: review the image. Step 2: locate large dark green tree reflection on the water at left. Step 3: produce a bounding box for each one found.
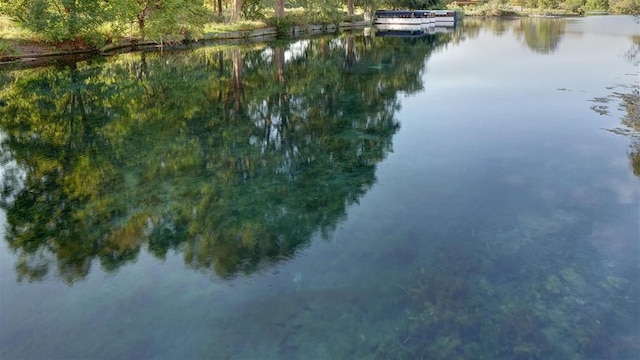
[0,34,450,283]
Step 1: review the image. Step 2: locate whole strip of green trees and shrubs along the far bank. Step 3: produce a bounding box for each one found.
[0,0,640,47]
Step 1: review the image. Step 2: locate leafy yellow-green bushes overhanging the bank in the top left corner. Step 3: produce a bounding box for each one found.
[0,0,207,46]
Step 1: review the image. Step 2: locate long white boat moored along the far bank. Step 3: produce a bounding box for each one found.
[373,10,457,26]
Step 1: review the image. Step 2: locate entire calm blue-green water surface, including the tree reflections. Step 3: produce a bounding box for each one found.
[0,16,640,359]
